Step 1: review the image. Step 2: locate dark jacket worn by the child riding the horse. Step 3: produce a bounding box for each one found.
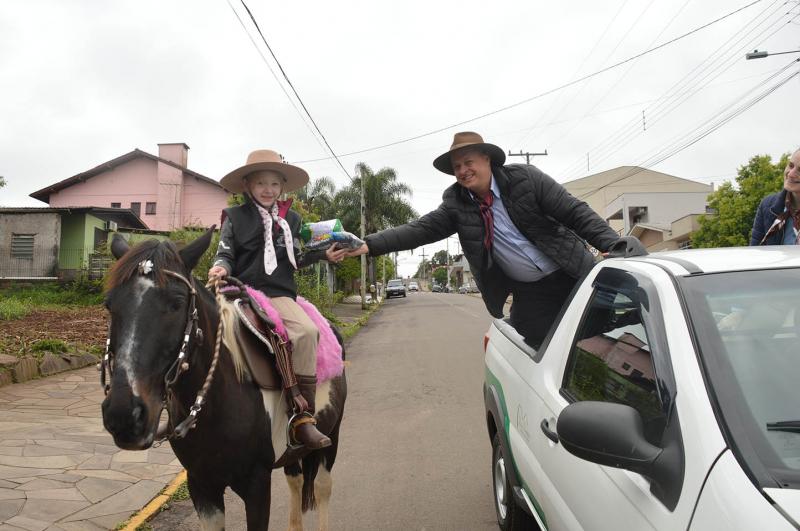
[214,198,325,299]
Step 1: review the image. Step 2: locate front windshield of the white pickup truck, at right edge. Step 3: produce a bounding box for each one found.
[680,268,800,489]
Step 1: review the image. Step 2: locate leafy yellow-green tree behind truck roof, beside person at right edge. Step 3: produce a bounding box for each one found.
[692,153,789,248]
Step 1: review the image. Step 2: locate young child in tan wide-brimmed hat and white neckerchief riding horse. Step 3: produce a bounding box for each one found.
[208,149,347,449]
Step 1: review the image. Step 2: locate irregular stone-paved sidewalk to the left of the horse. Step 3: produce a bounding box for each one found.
[0,367,181,531]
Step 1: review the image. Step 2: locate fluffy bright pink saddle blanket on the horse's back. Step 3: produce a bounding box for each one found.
[247,286,344,384]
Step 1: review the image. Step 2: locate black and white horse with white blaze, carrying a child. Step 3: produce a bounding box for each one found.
[101,231,347,530]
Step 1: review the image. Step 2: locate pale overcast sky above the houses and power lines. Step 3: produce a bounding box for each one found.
[0,0,800,275]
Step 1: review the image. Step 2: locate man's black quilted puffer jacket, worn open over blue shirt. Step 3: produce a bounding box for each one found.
[366,164,619,317]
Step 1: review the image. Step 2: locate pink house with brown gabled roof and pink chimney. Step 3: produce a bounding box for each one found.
[30,143,229,231]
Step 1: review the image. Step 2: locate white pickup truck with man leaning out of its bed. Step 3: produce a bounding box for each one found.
[484,246,800,531]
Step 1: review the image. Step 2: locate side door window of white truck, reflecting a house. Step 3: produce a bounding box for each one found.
[562,287,666,445]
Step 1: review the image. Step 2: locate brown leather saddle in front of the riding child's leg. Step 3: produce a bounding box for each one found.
[233,298,283,390]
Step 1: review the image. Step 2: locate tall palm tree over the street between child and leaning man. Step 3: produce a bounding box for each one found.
[334,162,419,282]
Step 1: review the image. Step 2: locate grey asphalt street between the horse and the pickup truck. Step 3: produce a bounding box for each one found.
[153,293,497,531]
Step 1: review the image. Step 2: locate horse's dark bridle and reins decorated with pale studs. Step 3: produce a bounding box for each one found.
[97,266,222,446]
